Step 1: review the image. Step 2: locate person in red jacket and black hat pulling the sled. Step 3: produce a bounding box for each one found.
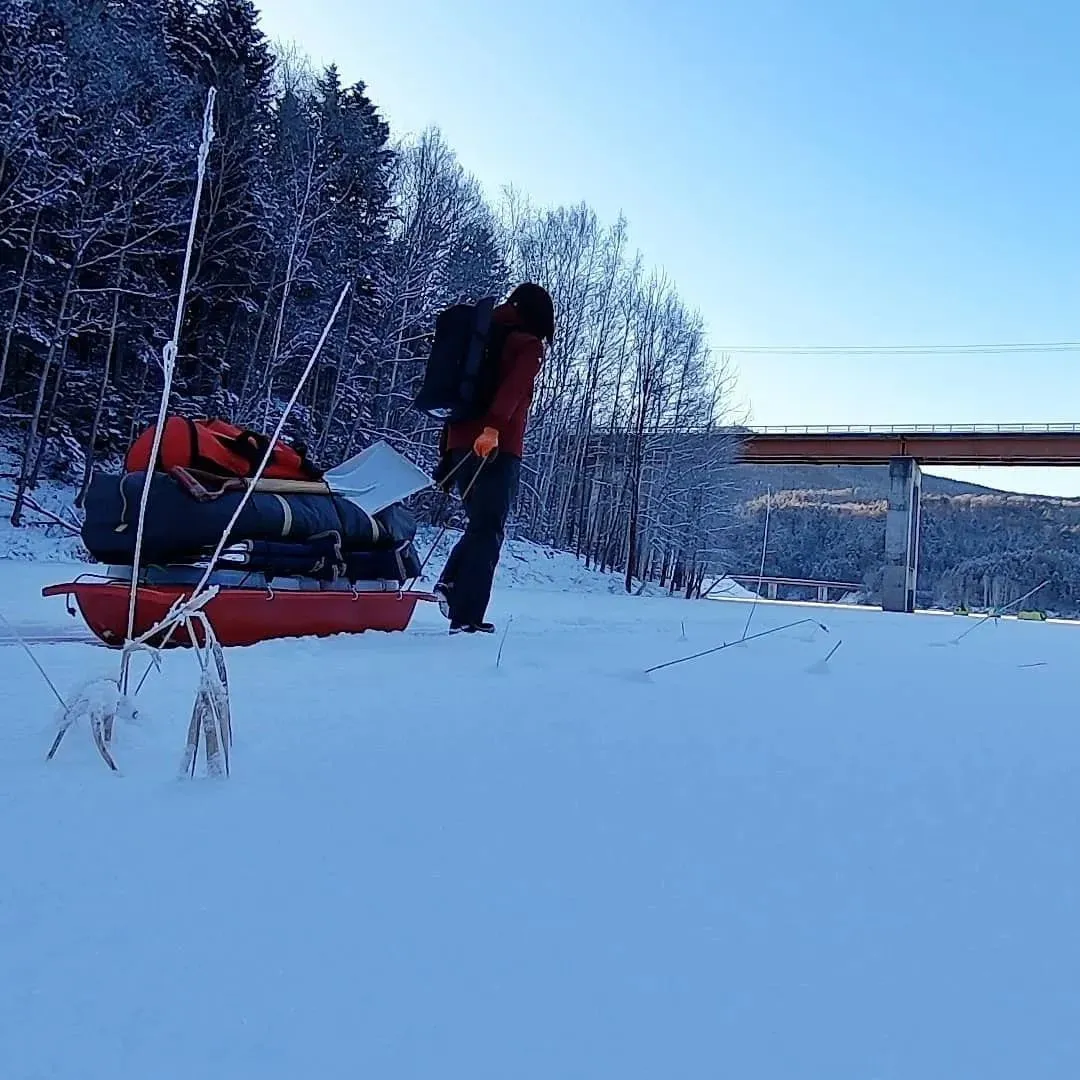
[434,284,555,634]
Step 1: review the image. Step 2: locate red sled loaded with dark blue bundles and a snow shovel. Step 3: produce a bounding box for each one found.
[43,421,435,648]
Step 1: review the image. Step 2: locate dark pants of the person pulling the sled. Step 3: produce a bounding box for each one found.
[438,450,522,626]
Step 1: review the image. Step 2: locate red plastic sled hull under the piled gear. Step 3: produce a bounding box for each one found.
[42,581,434,648]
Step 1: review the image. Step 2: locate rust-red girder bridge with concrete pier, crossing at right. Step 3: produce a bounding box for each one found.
[740,423,1080,612]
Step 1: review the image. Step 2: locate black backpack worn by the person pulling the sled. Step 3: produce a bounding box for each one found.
[413,297,509,423]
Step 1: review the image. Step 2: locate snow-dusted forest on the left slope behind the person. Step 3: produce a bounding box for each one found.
[0,0,729,596]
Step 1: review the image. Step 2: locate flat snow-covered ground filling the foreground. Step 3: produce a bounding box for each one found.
[0,563,1080,1080]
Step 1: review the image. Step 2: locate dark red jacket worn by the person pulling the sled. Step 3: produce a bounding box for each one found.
[445,303,543,458]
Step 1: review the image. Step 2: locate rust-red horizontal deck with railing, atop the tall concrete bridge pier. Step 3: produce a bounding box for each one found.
[740,424,1080,465]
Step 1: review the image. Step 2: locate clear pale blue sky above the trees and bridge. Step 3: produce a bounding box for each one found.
[256,0,1080,495]
